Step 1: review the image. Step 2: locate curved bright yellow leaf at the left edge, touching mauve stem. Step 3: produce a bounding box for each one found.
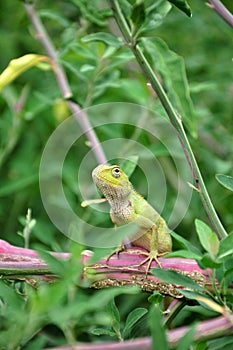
[0,54,49,92]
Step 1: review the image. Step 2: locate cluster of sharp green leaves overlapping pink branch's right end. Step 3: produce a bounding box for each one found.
[156,219,233,314]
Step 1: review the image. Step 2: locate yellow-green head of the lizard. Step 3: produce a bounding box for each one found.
[92,164,132,196]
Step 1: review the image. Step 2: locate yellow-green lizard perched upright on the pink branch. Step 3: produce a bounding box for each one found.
[90,164,172,274]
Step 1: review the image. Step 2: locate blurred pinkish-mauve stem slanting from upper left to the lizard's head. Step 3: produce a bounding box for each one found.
[24,3,106,163]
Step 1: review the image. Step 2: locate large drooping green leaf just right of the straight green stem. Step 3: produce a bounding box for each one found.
[142,38,196,137]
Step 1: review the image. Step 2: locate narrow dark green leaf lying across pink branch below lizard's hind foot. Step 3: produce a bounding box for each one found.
[151,269,205,291]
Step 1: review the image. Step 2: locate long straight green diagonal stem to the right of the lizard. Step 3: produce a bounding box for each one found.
[111,0,227,239]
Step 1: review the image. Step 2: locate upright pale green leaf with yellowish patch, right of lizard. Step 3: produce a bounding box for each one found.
[195,219,219,256]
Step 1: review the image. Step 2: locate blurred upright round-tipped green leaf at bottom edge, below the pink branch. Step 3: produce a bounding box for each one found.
[149,304,169,350]
